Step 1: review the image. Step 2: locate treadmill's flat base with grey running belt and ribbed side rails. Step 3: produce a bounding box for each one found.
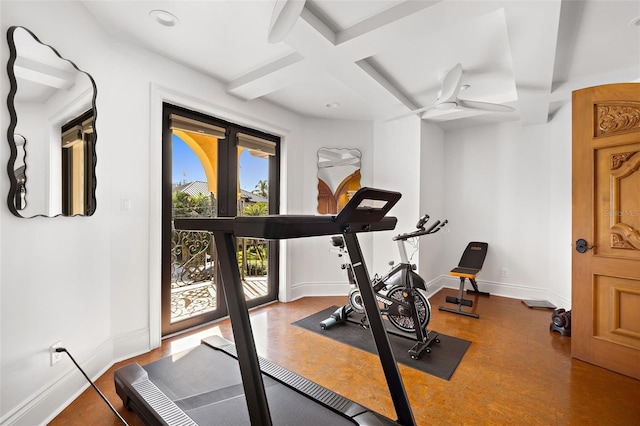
[115,336,395,426]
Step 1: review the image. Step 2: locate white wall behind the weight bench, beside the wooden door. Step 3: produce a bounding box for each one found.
[443,120,571,306]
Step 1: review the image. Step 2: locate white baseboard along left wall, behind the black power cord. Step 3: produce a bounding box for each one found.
[0,329,149,426]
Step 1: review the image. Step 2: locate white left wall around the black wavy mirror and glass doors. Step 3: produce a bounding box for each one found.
[0,1,304,425]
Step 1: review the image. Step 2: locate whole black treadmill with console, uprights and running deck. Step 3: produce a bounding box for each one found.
[114,188,415,426]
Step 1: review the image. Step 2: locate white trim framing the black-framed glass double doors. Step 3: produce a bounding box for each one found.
[149,83,290,349]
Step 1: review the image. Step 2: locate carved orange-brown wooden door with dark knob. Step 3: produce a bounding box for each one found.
[571,83,640,379]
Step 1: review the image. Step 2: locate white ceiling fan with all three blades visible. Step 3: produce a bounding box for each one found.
[387,64,514,121]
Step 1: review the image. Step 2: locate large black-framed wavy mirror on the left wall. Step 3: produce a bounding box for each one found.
[7,26,97,217]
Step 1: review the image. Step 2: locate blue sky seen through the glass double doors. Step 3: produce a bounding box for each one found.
[172,135,269,192]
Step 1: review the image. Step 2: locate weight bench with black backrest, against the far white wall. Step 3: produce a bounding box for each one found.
[438,242,489,318]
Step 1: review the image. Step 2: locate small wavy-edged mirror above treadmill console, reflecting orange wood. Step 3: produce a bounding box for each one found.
[318,148,362,214]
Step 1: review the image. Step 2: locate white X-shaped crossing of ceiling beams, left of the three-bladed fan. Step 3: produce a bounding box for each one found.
[227,0,495,105]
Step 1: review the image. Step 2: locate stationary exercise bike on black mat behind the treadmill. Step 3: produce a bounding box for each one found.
[320,215,447,359]
